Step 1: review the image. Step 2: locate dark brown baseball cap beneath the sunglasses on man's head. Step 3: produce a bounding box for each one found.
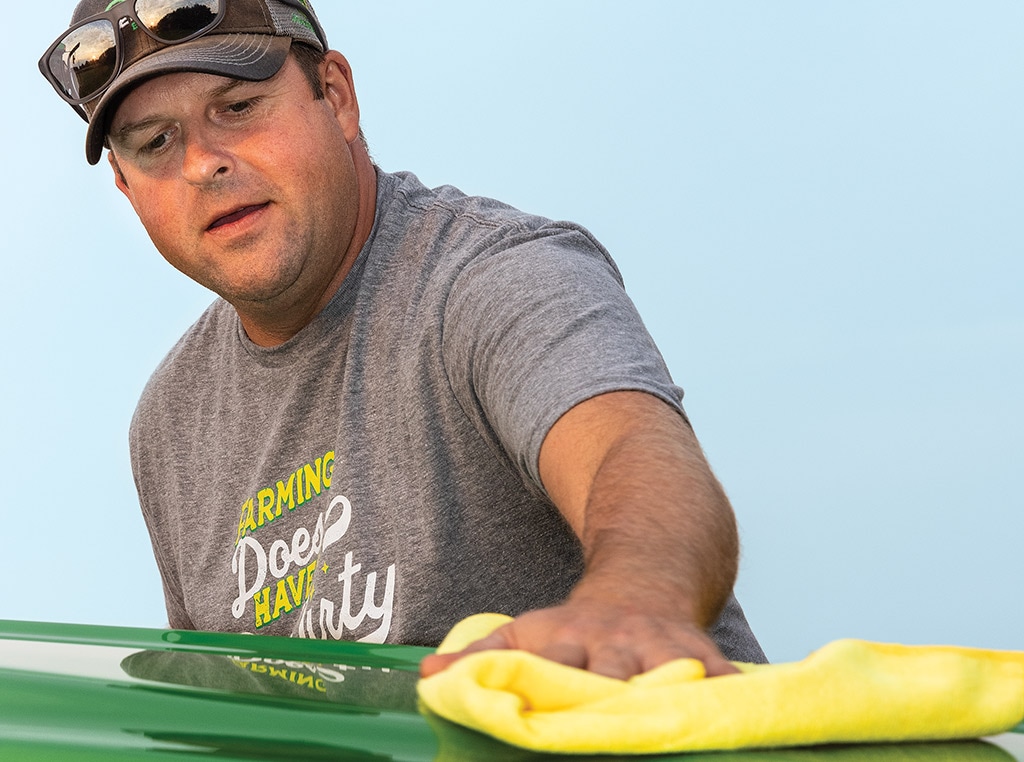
[48,0,328,164]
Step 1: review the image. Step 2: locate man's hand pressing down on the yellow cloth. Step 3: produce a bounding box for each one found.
[420,599,738,680]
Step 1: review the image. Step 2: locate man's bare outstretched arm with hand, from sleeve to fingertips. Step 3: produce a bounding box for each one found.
[421,391,738,679]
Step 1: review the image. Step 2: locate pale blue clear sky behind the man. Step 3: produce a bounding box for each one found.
[0,0,1024,660]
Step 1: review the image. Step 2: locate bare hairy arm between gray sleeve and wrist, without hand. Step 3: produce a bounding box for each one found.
[541,392,738,627]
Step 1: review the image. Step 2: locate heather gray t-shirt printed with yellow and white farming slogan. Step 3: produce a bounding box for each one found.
[130,173,760,661]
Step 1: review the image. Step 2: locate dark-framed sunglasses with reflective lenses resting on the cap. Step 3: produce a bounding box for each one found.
[39,0,227,113]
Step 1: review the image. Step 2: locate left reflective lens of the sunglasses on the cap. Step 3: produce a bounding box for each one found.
[47,18,118,100]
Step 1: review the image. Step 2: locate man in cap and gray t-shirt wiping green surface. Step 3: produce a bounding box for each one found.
[40,0,764,678]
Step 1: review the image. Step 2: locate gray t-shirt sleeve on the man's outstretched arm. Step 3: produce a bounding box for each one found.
[442,223,683,489]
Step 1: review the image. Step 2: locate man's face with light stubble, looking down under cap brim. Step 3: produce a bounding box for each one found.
[110,55,361,335]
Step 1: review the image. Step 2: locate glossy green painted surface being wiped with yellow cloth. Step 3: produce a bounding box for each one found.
[0,621,1024,762]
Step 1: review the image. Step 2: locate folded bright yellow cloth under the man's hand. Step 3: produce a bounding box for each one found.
[418,615,1024,754]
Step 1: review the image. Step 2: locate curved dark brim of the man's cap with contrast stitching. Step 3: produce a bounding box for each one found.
[85,34,292,164]
